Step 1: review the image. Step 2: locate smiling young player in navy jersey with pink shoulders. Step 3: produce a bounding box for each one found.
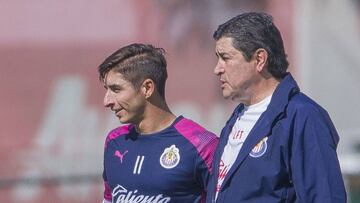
[99,44,218,203]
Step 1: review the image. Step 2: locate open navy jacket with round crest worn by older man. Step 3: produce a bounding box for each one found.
[207,74,346,203]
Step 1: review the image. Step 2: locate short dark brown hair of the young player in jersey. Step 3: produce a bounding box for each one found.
[99,43,167,99]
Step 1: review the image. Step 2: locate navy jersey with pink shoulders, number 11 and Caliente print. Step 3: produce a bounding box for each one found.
[103,116,218,203]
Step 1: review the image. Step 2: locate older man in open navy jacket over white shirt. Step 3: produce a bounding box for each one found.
[207,12,346,203]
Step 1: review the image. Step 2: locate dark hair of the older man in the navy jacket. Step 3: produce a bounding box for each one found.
[213,12,289,78]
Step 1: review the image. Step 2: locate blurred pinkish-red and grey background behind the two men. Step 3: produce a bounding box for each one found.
[0,0,360,203]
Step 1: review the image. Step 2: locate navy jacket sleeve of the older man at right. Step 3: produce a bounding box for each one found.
[290,109,346,203]
